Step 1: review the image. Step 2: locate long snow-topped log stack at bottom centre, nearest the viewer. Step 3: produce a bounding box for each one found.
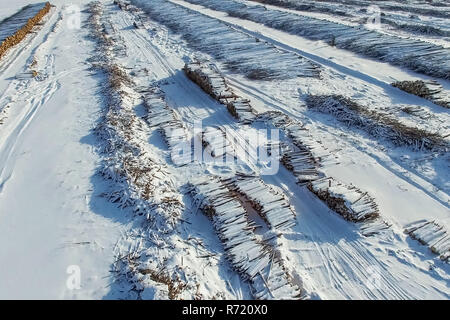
[192,178,301,299]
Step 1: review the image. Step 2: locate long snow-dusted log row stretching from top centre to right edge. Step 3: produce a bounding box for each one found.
[188,0,450,79]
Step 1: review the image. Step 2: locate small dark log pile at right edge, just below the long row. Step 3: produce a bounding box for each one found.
[392,80,450,108]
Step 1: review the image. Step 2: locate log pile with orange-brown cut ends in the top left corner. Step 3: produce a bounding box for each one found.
[0,2,51,59]
